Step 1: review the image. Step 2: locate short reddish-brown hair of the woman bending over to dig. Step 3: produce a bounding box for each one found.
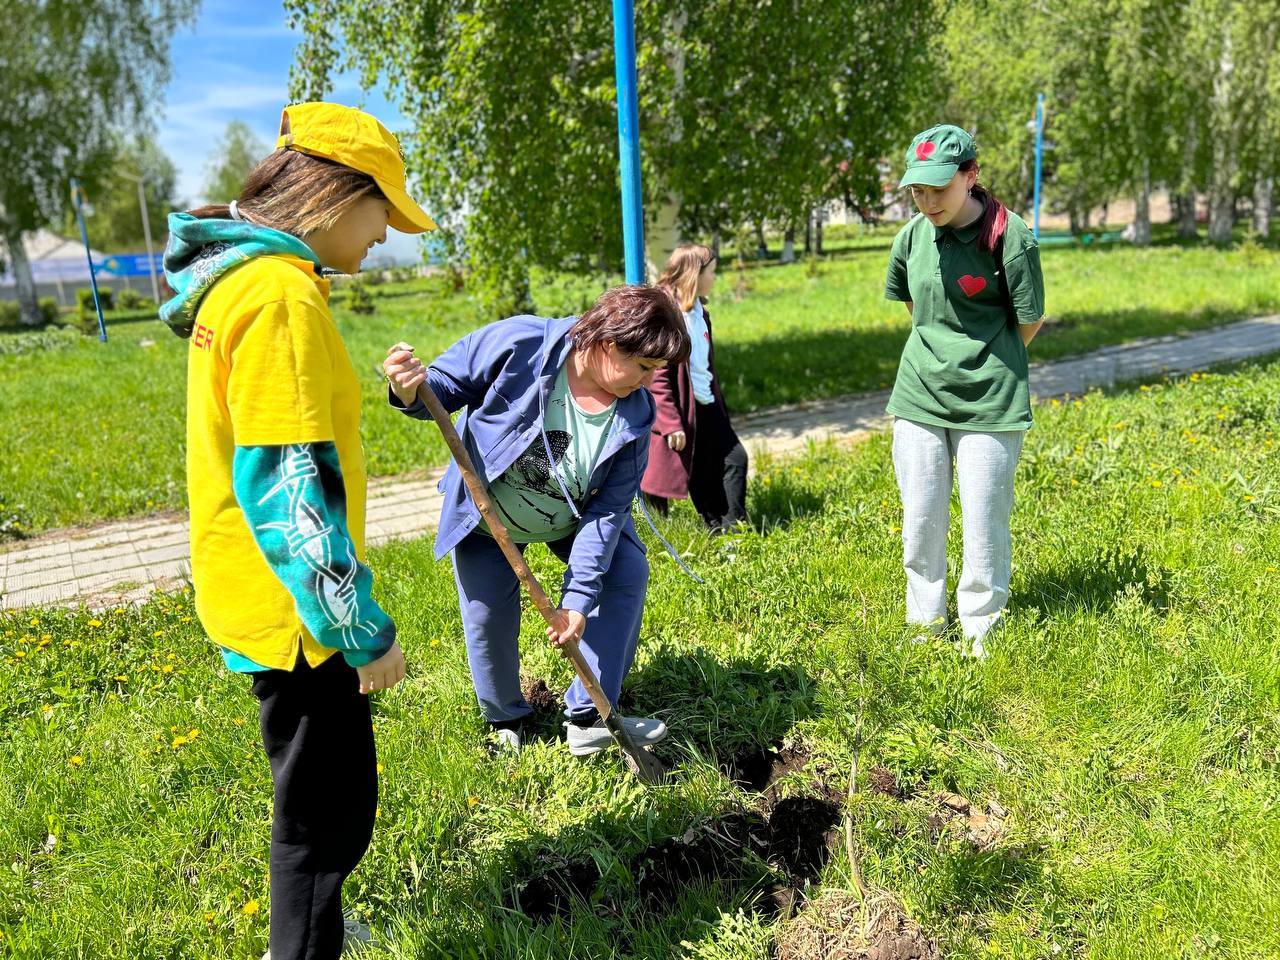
[570,284,689,365]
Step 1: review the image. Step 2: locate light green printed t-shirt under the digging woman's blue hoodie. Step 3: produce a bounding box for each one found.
[480,365,618,543]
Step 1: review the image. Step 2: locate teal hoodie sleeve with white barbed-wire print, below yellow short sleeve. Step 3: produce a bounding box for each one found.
[232,440,396,667]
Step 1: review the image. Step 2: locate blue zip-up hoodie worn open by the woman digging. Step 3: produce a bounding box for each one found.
[388,316,657,616]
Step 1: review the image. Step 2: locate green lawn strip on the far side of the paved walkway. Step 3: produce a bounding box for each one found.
[0,236,1280,536]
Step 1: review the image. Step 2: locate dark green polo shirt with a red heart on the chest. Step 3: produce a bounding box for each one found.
[884,211,1044,431]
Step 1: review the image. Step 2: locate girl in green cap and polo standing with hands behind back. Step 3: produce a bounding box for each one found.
[884,124,1044,658]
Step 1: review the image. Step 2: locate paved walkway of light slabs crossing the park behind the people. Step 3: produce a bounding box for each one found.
[0,316,1280,609]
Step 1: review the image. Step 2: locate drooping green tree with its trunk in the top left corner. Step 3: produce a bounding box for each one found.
[0,0,198,325]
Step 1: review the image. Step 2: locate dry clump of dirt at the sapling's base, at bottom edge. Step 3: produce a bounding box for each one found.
[777,891,942,960]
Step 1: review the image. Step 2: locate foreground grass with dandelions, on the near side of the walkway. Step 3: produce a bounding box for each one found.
[0,361,1280,960]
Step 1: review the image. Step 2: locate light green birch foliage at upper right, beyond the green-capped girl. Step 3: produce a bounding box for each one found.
[941,0,1280,242]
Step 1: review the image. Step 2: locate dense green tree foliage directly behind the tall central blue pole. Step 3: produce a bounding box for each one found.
[285,0,936,312]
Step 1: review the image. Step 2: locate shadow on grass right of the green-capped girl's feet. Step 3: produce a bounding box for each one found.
[1014,544,1172,612]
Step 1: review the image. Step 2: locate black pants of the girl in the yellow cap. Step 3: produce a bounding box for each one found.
[253,654,378,960]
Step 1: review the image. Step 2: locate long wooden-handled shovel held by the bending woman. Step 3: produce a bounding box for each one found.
[417,384,667,783]
